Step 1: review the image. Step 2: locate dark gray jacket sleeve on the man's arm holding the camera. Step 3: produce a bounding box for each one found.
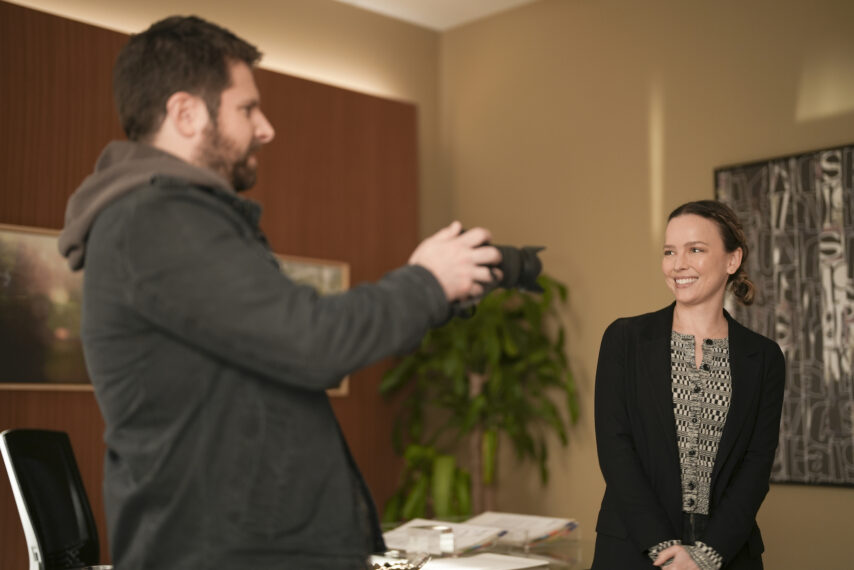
[117,184,449,389]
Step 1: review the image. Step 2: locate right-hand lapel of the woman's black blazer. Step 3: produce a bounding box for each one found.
[712,311,760,483]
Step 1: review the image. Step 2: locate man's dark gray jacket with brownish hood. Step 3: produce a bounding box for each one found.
[60,142,449,570]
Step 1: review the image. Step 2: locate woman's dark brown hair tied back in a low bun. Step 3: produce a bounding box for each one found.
[667,200,756,305]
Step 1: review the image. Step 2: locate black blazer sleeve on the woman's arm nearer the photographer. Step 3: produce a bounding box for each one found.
[595,320,680,552]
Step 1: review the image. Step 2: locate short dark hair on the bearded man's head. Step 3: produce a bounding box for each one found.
[113,16,261,141]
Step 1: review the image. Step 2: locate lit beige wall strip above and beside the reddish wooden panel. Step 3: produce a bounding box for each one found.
[8,0,451,236]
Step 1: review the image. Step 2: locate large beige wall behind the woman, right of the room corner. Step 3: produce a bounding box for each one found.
[439,0,854,570]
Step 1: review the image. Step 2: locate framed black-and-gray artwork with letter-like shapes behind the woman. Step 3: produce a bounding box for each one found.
[715,145,854,486]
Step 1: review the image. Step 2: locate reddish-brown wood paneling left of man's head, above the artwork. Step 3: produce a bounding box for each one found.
[0,2,127,229]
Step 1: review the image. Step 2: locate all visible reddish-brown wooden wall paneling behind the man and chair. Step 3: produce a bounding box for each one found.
[0,2,417,568]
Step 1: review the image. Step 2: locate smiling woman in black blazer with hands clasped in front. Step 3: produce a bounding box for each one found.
[593,200,785,570]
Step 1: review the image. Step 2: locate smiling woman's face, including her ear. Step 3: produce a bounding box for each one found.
[661,214,741,306]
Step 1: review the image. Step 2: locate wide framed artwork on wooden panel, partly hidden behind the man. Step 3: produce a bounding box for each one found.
[0,224,350,396]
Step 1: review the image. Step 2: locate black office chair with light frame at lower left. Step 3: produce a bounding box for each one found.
[0,429,112,570]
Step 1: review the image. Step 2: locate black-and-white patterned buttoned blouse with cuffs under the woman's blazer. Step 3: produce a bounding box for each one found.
[649,331,732,570]
